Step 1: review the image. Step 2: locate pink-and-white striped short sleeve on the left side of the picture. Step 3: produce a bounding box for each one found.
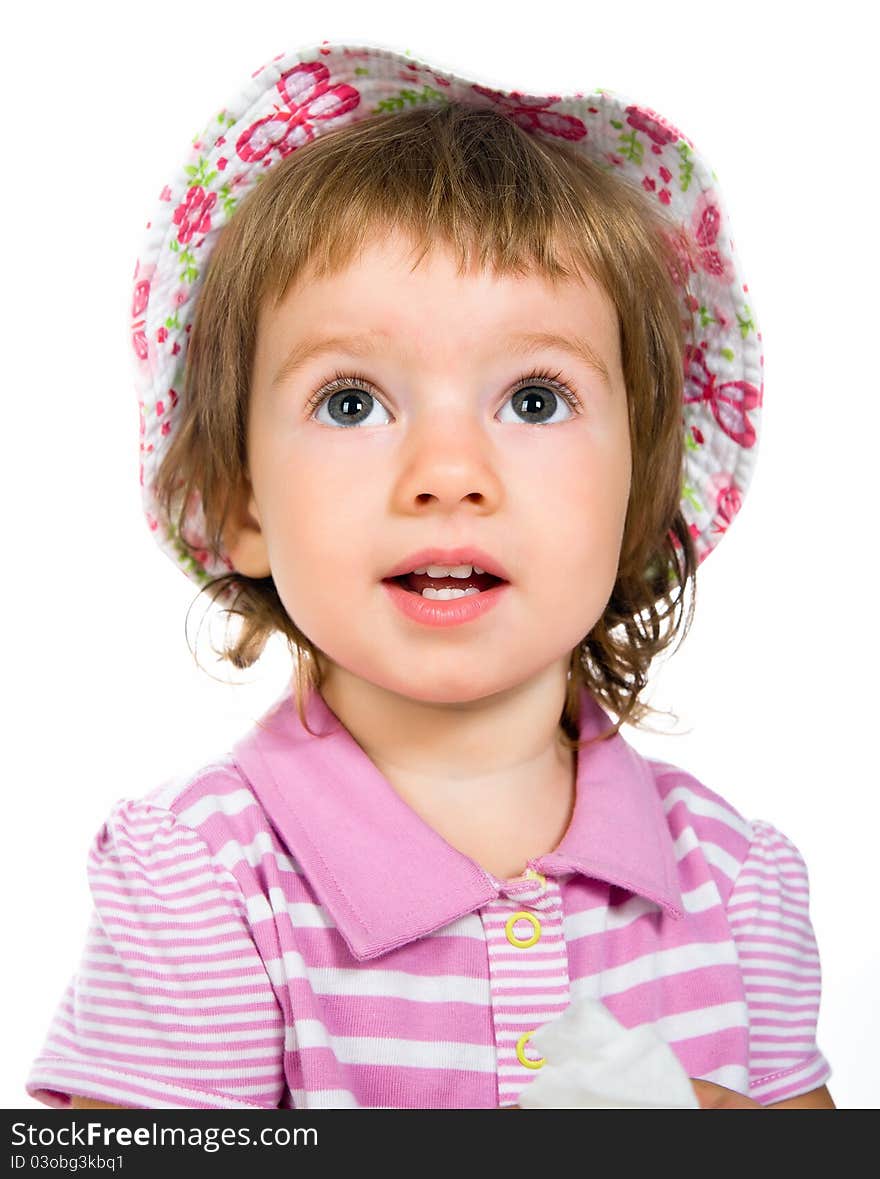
[27,802,285,1109]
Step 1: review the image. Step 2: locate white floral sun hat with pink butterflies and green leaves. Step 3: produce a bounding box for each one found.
[131,42,763,585]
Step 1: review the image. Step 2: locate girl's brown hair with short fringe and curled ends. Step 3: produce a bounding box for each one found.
[157,103,697,749]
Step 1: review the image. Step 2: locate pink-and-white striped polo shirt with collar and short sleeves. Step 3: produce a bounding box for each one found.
[27,691,830,1109]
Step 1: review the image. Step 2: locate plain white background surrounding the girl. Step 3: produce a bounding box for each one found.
[0,0,880,1108]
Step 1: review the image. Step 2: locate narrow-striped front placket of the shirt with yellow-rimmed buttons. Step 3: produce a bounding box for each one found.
[480,867,570,1105]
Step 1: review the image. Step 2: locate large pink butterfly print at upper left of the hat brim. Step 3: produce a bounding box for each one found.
[235,61,361,164]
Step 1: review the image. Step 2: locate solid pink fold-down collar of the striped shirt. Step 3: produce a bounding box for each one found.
[232,689,684,960]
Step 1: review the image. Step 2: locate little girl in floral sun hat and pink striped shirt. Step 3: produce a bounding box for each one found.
[28,36,833,1109]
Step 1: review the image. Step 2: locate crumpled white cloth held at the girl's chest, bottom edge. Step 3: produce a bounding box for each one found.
[519,999,700,1109]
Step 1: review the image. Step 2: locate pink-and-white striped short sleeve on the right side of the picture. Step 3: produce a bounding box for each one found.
[728,822,830,1105]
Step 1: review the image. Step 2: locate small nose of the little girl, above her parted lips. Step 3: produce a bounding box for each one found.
[395,413,503,513]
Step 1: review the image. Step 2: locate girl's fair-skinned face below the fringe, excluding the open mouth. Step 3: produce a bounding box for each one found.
[233,236,631,704]
